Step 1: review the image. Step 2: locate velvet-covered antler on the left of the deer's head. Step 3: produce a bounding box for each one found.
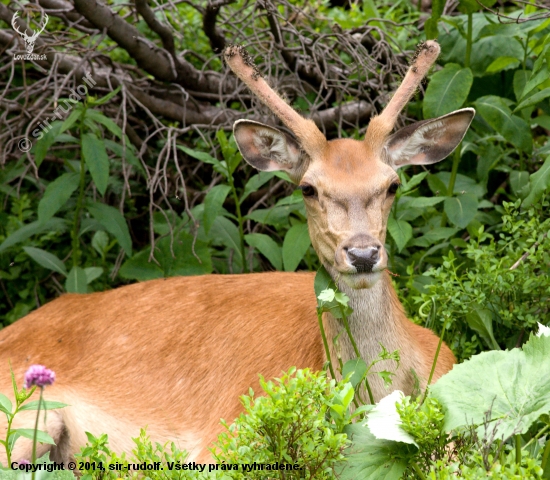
[223,45,327,156]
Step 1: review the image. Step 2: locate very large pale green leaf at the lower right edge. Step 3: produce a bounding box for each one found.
[430,336,550,438]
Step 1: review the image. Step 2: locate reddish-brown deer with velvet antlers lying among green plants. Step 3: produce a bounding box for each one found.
[0,41,475,463]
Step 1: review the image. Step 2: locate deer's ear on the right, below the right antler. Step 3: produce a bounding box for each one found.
[384,108,476,169]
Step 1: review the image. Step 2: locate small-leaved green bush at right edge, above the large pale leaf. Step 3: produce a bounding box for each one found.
[416,200,550,358]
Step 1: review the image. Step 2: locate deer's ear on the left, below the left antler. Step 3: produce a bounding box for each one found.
[233,120,309,182]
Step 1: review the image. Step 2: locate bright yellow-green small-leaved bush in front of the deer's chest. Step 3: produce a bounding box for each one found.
[213,369,353,479]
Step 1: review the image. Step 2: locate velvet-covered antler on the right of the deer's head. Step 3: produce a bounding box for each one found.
[365,40,441,154]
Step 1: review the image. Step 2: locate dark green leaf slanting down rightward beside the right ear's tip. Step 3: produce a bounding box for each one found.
[475,95,533,153]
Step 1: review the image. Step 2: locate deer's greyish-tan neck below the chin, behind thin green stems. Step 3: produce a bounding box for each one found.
[323,273,421,401]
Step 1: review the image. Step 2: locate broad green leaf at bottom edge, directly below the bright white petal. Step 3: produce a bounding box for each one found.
[336,423,416,480]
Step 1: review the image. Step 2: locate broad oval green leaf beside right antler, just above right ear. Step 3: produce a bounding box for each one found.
[423,63,474,118]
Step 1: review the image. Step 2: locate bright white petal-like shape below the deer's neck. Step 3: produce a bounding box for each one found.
[366,390,418,447]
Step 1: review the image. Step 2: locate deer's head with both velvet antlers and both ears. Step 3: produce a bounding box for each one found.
[224,41,475,289]
